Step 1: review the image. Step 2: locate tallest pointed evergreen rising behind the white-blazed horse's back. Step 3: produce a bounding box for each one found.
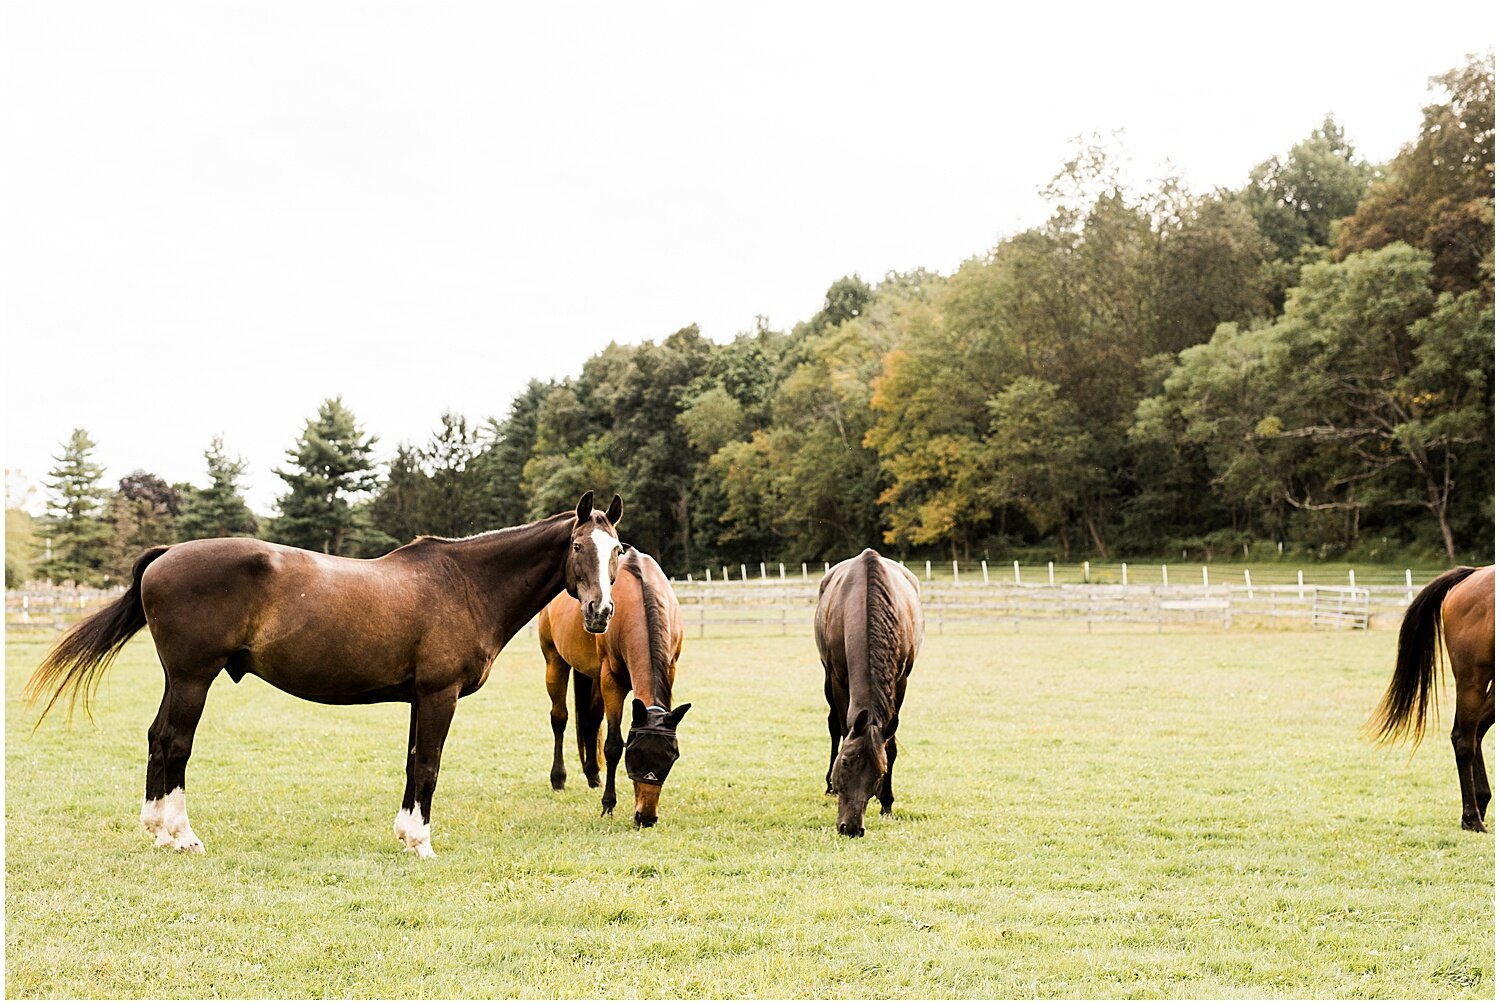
[272,398,378,555]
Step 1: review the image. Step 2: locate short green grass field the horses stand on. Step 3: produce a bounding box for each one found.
[6,632,1496,999]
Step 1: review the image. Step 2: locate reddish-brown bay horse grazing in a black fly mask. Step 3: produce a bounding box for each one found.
[537,548,692,827]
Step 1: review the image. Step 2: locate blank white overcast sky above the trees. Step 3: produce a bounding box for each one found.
[0,0,1494,513]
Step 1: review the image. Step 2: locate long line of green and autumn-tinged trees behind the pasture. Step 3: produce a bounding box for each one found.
[8,56,1494,579]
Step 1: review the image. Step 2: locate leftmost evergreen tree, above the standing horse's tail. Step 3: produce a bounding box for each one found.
[41,429,110,585]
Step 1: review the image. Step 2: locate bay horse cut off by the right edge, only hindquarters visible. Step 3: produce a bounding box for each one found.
[1368,566,1496,831]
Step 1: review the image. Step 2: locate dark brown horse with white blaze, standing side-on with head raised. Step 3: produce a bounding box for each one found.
[26,492,623,858]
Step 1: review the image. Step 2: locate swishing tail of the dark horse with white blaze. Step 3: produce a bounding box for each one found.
[21,545,168,725]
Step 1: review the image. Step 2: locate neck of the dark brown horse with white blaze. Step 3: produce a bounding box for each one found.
[452,513,573,651]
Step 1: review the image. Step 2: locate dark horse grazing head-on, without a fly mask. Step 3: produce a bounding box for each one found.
[813,548,923,837]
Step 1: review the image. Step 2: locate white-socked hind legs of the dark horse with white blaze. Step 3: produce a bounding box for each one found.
[141,675,213,854]
